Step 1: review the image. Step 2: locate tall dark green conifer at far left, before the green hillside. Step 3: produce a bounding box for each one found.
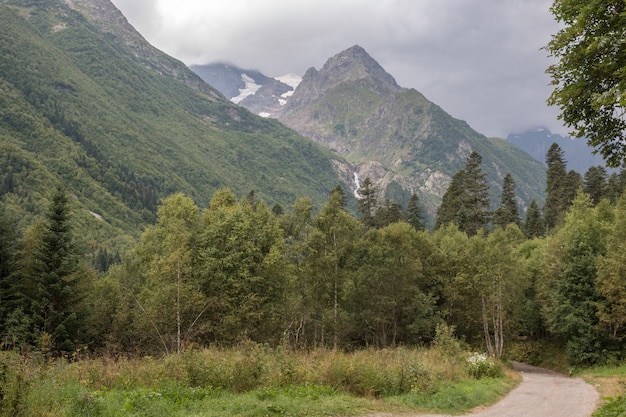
[31,187,86,354]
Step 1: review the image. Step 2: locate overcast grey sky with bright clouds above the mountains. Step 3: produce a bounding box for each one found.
[112,0,566,137]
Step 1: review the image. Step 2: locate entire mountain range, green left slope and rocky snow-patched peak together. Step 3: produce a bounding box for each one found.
[0,0,560,255]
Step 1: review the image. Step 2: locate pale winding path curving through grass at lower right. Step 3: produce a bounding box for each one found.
[368,363,600,417]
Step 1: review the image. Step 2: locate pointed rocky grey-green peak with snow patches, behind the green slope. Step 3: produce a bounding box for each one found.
[192,45,545,216]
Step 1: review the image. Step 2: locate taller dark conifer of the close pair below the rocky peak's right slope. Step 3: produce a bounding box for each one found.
[459,151,492,236]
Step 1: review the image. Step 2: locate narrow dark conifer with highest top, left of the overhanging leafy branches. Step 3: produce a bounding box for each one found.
[543,142,576,230]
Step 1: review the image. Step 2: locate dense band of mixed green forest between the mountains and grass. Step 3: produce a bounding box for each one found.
[0,145,626,364]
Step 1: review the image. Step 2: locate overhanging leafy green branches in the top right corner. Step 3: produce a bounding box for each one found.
[547,0,626,167]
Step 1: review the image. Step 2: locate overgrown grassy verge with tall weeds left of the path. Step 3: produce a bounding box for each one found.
[0,345,517,417]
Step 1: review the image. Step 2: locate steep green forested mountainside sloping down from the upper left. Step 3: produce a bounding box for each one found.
[0,0,338,247]
